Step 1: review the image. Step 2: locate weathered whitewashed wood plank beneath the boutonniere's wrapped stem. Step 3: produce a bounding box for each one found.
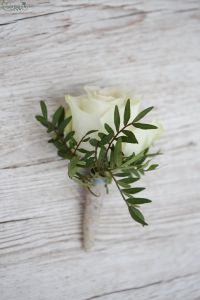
[0,146,200,300]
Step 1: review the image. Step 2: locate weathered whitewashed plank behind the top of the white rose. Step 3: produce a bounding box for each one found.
[0,0,200,167]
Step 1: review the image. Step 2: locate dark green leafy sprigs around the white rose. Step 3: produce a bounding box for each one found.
[36,99,160,226]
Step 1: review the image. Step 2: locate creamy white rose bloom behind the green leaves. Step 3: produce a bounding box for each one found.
[65,86,163,155]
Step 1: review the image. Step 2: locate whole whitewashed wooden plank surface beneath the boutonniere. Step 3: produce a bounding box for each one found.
[0,0,200,300]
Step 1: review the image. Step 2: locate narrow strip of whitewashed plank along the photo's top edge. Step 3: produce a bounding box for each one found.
[0,0,200,25]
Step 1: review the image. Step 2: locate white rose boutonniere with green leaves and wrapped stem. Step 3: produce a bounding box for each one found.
[36,87,163,250]
